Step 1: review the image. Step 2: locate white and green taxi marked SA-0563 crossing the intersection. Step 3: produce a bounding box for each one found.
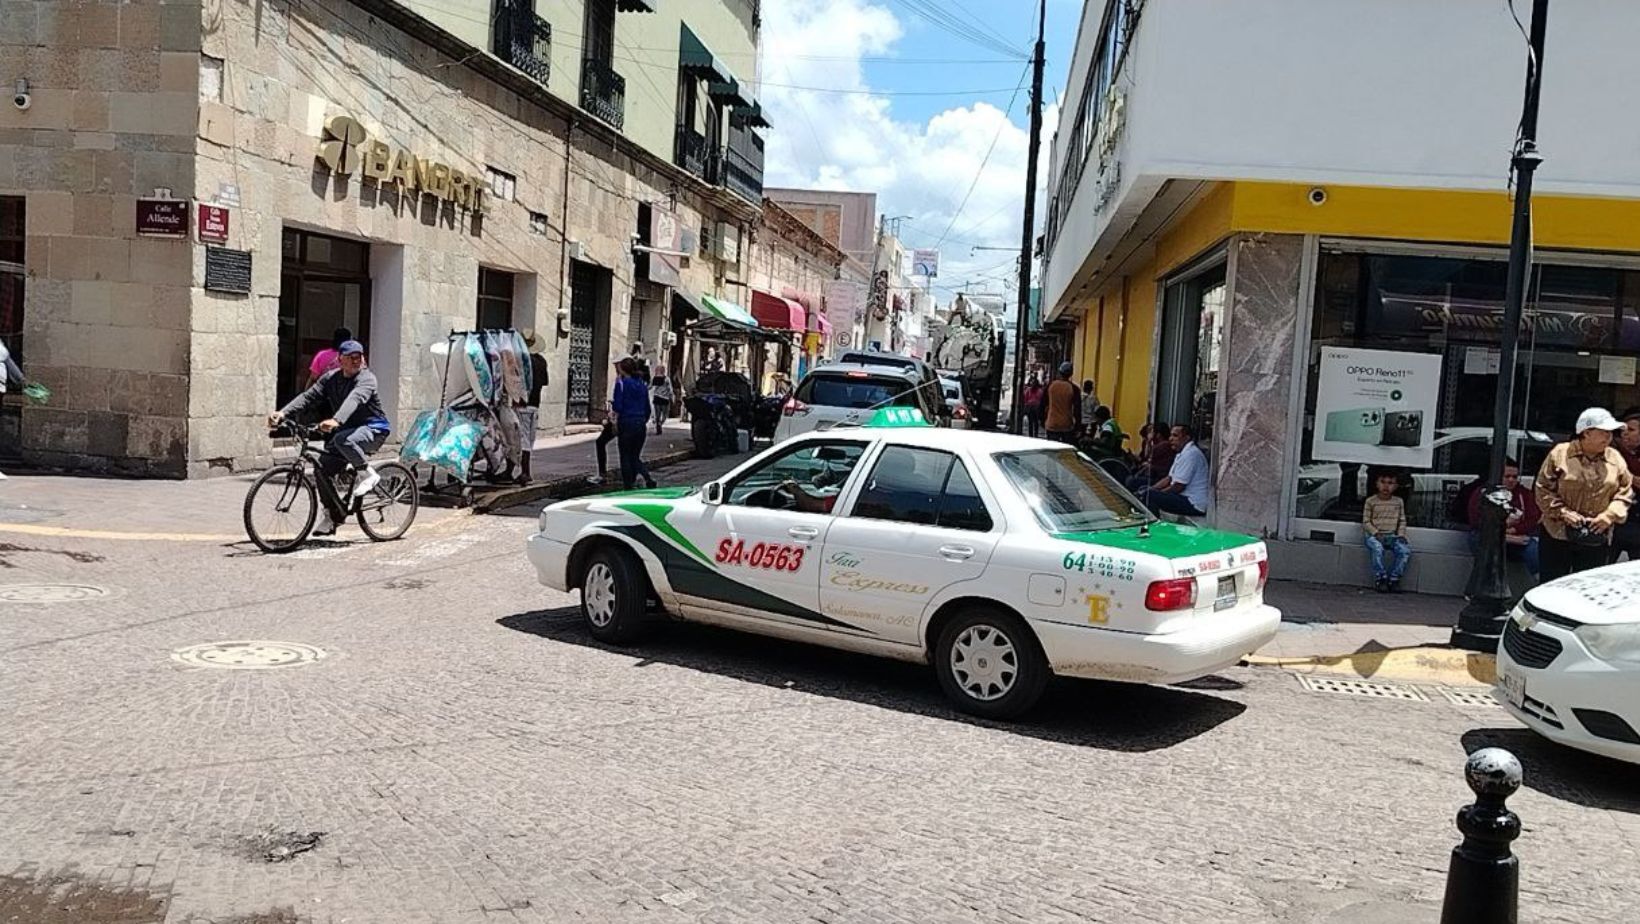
[526,409,1281,717]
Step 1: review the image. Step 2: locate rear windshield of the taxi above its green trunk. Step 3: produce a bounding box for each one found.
[997,448,1155,533]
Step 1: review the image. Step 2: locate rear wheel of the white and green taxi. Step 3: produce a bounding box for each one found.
[933,607,1050,719]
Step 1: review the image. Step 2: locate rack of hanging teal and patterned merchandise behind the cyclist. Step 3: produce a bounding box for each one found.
[399,328,535,504]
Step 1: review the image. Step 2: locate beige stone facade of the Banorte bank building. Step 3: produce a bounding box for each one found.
[0,0,761,476]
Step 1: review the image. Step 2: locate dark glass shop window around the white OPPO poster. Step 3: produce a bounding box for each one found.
[1292,246,1640,538]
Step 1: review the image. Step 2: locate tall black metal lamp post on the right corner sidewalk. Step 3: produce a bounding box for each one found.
[1451,0,1548,652]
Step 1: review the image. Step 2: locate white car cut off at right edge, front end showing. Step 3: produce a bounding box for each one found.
[1494,561,1640,763]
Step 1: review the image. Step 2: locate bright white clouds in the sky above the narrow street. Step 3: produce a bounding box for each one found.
[759,0,1056,302]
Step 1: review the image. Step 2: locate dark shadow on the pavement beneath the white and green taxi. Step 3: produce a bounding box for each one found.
[495,609,1246,753]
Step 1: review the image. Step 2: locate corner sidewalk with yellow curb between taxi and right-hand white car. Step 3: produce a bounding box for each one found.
[1248,581,1497,686]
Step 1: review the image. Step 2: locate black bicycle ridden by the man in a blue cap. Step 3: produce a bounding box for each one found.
[244,420,421,553]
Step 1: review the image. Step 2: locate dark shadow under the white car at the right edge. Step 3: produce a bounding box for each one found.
[1463,729,1640,824]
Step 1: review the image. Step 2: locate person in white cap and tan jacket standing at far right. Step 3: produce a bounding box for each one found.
[1532,407,1633,584]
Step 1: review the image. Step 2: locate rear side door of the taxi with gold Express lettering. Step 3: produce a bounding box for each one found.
[820,443,1002,645]
